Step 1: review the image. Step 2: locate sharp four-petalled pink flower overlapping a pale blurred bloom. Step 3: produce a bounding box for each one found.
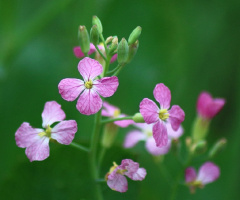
[140,83,185,147]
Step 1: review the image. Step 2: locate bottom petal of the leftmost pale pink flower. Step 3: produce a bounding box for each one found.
[25,136,49,162]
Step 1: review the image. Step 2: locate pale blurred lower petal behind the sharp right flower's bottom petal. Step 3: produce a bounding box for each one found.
[146,137,171,156]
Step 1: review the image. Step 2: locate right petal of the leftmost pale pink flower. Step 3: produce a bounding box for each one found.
[51,120,77,145]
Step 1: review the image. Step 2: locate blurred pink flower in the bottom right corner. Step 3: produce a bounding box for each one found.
[185,162,220,192]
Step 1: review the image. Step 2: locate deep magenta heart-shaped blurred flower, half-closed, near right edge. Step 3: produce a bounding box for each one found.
[197,92,225,119]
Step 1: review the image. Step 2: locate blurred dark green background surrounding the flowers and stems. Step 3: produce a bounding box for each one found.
[0,0,240,200]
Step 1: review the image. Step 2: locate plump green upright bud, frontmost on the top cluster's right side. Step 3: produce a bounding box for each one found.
[117,38,129,65]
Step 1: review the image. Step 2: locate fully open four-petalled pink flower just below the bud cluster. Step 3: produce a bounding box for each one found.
[58,57,119,115]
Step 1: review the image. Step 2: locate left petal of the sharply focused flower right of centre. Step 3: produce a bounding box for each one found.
[139,98,159,124]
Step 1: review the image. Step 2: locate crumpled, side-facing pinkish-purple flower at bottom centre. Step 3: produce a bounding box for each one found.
[106,159,147,192]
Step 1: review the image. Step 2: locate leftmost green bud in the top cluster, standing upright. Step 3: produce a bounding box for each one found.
[78,26,90,54]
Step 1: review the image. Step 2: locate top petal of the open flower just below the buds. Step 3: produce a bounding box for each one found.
[78,57,103,81]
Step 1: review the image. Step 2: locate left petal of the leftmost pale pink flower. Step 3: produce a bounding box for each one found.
[15,122,44,148]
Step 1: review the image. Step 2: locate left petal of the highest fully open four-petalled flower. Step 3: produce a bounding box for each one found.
[58,78,85,101]
